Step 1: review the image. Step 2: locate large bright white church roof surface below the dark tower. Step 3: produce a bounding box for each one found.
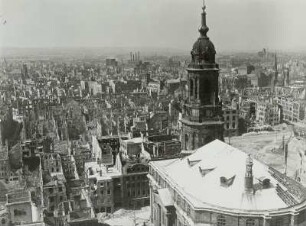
[151,140,306,211]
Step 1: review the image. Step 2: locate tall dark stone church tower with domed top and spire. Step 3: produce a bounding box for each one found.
[181,2,224,151]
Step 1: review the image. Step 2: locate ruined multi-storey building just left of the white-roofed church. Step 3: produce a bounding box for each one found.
[85,160,149,213]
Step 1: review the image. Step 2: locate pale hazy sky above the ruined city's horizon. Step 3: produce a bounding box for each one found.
[0,0,306,51]
